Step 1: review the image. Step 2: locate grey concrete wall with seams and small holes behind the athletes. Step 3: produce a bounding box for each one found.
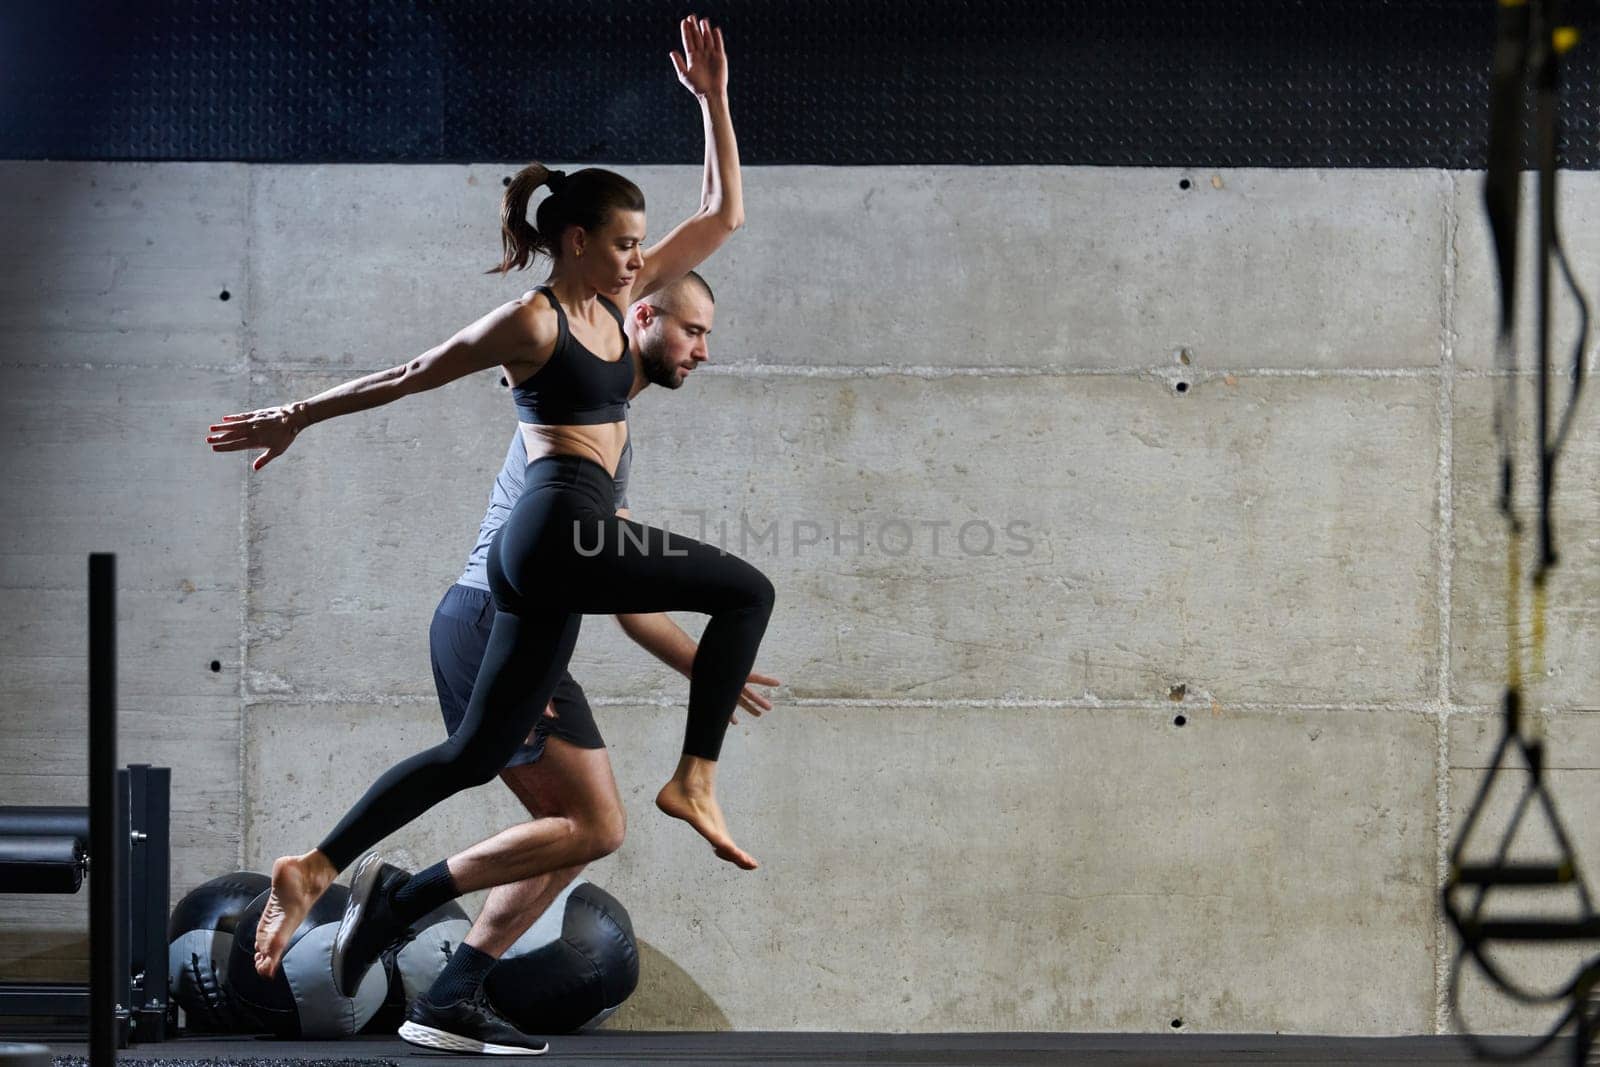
[0,163,1600,1035]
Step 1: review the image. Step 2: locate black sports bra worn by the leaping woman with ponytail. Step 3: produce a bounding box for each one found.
[510,285,634,426]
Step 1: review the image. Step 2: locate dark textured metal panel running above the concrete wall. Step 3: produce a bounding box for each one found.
[0,0,1600,168]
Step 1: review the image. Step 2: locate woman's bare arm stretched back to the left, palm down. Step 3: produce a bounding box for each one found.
[205,301,557,470]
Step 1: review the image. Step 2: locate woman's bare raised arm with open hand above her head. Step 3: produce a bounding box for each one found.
[629,16,744,302]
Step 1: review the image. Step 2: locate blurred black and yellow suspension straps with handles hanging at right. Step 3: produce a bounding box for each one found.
[1442,0,1600,1064]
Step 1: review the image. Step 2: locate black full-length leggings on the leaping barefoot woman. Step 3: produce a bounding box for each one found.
[318,456,773,869]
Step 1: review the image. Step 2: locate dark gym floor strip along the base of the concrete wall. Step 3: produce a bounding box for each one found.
[25,1030,1573,1067]
